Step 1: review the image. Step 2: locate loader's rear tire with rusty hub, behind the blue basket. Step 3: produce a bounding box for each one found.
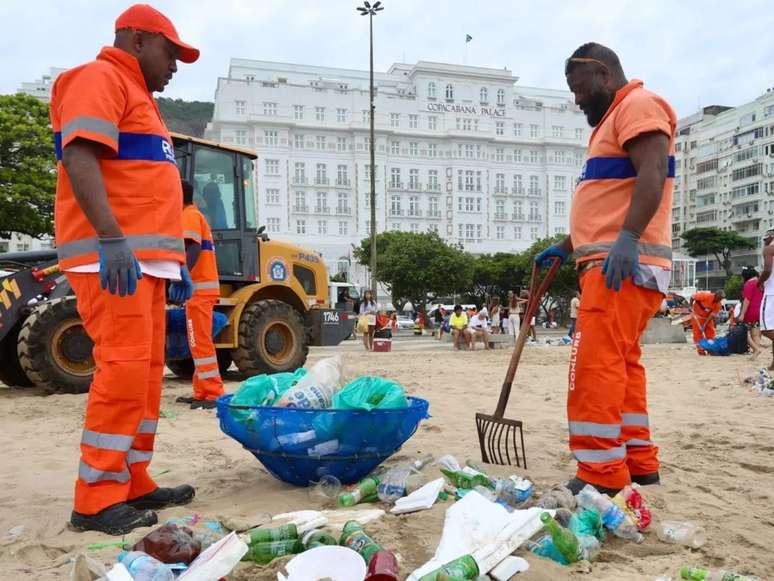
[231,300,309,377]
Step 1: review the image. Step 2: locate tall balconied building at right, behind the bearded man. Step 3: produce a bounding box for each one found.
[672,90,774,288]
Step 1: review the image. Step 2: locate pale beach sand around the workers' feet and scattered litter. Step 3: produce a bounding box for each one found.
[0,345,774,581]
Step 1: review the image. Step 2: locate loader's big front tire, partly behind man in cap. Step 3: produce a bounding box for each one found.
[18,296,95,393]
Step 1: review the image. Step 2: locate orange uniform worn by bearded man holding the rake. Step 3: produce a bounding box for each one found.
[567,80,677,488]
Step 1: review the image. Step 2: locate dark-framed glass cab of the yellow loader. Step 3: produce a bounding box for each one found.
[172,133,260,282]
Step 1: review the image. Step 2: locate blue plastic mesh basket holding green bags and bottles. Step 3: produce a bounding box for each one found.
[217,394,430,486]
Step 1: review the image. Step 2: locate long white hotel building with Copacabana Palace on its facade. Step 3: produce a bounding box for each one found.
[206,59,589,278]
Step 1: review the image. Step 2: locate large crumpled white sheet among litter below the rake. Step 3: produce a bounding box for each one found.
[408,491,553,581]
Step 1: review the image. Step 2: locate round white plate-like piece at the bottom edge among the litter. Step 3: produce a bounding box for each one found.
[277,546,366,581]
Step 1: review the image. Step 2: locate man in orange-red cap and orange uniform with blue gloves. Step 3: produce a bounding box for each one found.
[51,4,199,535]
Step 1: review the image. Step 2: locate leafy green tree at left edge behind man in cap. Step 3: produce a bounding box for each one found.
[0,94,56,238]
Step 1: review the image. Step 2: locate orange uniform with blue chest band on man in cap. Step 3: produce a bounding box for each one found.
[51,47,185,515]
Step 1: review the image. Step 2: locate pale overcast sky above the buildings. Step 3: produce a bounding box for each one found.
[0,0,774,117]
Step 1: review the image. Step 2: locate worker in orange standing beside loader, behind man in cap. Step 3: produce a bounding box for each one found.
[177,181,223,409]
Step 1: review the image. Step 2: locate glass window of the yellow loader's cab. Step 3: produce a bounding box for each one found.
[193,147,239,230]
